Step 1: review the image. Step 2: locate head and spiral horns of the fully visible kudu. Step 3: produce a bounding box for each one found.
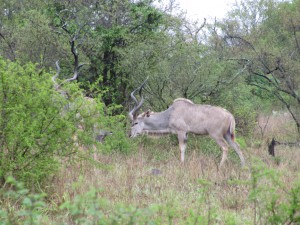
[128,78,148,137]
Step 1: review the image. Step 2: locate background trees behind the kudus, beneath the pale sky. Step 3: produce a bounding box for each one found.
[0,0,300,125]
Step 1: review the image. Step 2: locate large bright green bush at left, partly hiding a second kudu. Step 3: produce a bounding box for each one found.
[0,59,101,186]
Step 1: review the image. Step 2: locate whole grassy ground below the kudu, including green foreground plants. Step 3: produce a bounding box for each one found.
[0,112,300,225]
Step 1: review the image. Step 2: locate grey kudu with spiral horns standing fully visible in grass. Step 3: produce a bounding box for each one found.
[129,81,245,166]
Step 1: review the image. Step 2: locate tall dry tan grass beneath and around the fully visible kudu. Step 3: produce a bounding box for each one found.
[49,114,300,224]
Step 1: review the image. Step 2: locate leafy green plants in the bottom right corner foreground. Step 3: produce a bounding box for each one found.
[229,160,300,224]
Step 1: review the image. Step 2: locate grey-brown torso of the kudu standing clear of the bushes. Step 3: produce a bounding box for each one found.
[169,99,235,136]
